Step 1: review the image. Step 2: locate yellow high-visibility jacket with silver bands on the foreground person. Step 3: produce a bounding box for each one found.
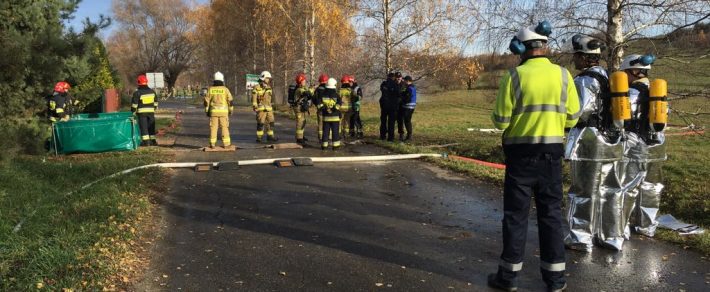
[493,57,580,147]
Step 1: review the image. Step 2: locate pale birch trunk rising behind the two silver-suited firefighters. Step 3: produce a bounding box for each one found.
[606,0,624,72]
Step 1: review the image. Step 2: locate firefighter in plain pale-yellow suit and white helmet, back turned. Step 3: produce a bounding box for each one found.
[204,72,234,148]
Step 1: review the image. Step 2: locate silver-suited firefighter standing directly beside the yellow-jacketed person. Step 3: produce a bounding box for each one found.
[565,34,626,252]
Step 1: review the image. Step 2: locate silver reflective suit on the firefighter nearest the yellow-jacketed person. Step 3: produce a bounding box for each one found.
[565,66,633,251]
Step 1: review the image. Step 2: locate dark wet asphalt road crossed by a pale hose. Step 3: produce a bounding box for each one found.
[135,103,710,291]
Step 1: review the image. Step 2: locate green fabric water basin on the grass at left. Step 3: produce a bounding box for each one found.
[54,112,140,154]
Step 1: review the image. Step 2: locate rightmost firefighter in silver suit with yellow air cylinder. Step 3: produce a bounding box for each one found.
[620,54,667,237]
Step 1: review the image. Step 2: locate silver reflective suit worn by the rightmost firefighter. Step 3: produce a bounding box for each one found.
[621,78,667,238]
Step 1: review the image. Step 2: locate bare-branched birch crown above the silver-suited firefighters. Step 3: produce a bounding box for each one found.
[482,0,710,70]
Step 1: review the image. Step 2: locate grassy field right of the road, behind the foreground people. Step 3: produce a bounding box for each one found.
[361,90,710,254]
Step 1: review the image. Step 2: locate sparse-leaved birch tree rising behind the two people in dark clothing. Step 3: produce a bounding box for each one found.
[356,0,478,78]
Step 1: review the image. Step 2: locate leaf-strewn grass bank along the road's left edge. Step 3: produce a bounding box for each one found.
[0,148,170,291]
